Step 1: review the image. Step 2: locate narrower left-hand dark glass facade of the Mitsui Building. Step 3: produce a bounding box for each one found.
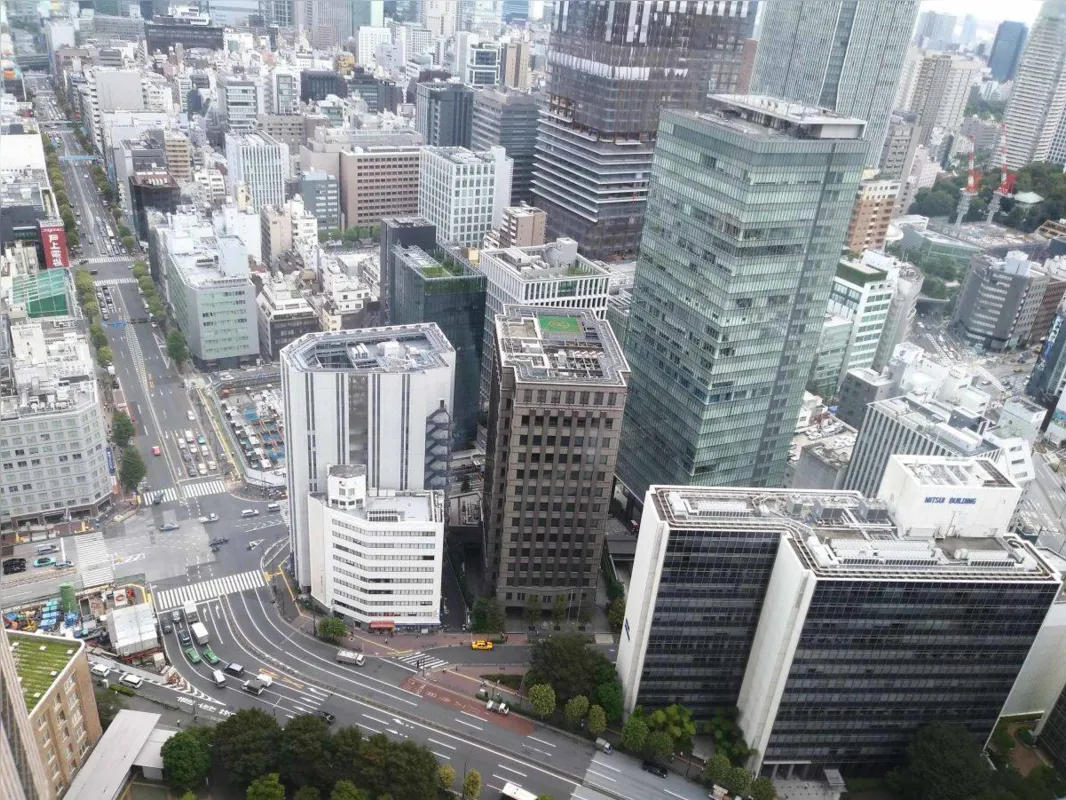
[637,526,781,719]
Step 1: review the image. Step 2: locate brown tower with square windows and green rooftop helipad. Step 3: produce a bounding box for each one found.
[482,306,629,617]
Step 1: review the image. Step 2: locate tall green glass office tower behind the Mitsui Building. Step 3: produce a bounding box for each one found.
[614,97,867,501]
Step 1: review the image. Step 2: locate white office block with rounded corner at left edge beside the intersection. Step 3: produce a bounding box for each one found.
[0,318,113,529]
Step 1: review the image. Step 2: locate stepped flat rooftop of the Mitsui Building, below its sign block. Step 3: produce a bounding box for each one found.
[649,486,1061,585]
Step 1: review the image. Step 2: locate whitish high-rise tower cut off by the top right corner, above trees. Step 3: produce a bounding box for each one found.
[1003,0,1066,170]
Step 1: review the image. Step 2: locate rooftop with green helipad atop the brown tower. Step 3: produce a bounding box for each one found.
[496,306,629,386]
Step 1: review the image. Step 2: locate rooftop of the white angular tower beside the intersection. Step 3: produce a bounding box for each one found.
[281,322,455,373]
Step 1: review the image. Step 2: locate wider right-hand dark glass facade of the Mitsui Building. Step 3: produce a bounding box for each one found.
[763,576,1057,773]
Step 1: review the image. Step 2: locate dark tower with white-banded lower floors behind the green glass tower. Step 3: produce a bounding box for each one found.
[533,0,756,258]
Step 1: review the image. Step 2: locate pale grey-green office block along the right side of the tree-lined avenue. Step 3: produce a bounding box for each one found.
[157,214,259,368]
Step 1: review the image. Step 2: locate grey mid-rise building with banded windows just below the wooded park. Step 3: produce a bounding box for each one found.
[952,251,1050,351]
